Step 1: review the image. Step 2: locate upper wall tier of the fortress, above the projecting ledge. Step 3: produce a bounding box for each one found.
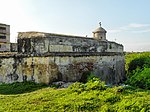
[18,36,123,54]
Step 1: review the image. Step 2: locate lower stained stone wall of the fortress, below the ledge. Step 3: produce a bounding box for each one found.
[0,53,125,84]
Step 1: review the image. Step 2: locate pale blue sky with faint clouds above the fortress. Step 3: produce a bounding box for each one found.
[0,0,150,52]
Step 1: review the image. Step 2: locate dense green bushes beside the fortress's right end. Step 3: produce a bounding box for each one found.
[126,52,150,89]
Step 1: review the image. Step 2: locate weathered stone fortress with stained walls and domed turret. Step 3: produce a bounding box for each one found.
[0,24,126,84]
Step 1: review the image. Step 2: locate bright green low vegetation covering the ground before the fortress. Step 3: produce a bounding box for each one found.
[0,79,150,112]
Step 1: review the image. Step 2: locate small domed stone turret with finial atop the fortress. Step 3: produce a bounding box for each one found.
[93,22,107,41]
